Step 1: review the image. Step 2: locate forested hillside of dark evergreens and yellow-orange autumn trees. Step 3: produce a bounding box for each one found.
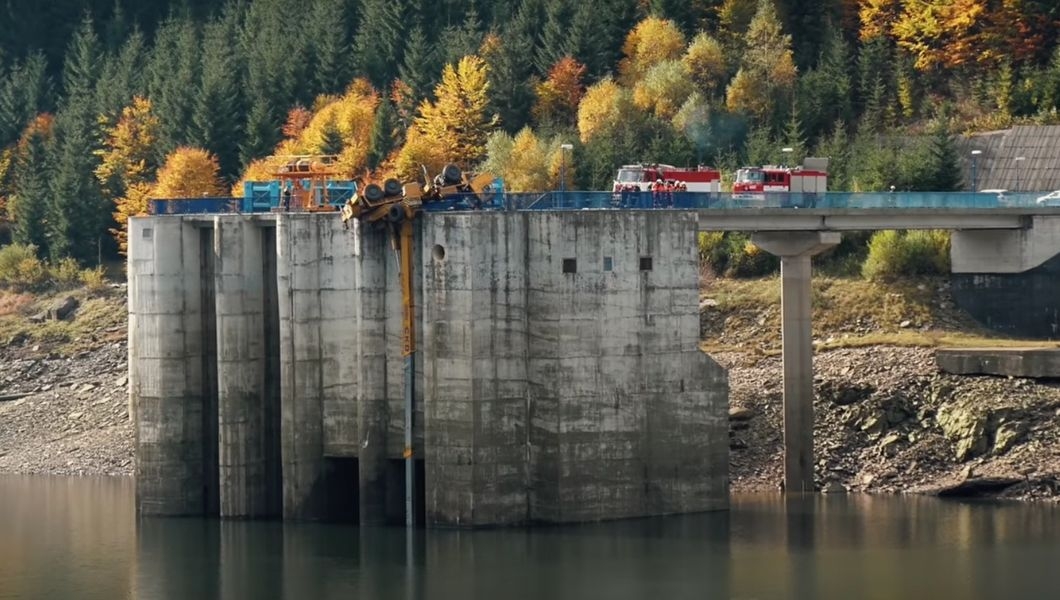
[0,0,1060,264]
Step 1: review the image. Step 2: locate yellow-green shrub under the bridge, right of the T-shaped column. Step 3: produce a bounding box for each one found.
[862,231,950,281]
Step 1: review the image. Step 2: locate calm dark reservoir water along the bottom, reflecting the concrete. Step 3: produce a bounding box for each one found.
[0,477,1060,600]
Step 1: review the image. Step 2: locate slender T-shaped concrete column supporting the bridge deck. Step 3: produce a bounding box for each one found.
[752,231,841,493]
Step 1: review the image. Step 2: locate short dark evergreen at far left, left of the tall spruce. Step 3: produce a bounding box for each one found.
[12,121,50,254]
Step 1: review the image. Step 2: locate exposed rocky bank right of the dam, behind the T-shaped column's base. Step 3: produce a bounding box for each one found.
[714,347,1060,499]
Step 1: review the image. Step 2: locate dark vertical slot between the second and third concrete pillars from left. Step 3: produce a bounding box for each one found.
[262,227,283,516]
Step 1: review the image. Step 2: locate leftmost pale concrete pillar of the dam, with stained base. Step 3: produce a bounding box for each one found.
[128,217,208,515]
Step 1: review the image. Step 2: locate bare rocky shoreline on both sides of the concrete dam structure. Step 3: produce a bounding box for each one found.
[0,292,1060,500]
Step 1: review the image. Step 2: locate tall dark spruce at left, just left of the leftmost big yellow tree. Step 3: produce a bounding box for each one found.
[46,17,110,261]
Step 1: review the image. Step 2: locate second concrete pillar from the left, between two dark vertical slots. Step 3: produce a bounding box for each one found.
[214,216,275,517]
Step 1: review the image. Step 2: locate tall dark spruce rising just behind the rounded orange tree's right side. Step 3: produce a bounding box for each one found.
[189,10,246,178]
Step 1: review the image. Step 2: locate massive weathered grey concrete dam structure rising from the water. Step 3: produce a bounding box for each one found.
[128,211,728,527]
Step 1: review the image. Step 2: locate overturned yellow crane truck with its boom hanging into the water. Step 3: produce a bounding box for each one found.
[342,164,494,527]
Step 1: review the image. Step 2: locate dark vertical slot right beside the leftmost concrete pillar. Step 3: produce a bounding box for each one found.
[199,228,220,516]
